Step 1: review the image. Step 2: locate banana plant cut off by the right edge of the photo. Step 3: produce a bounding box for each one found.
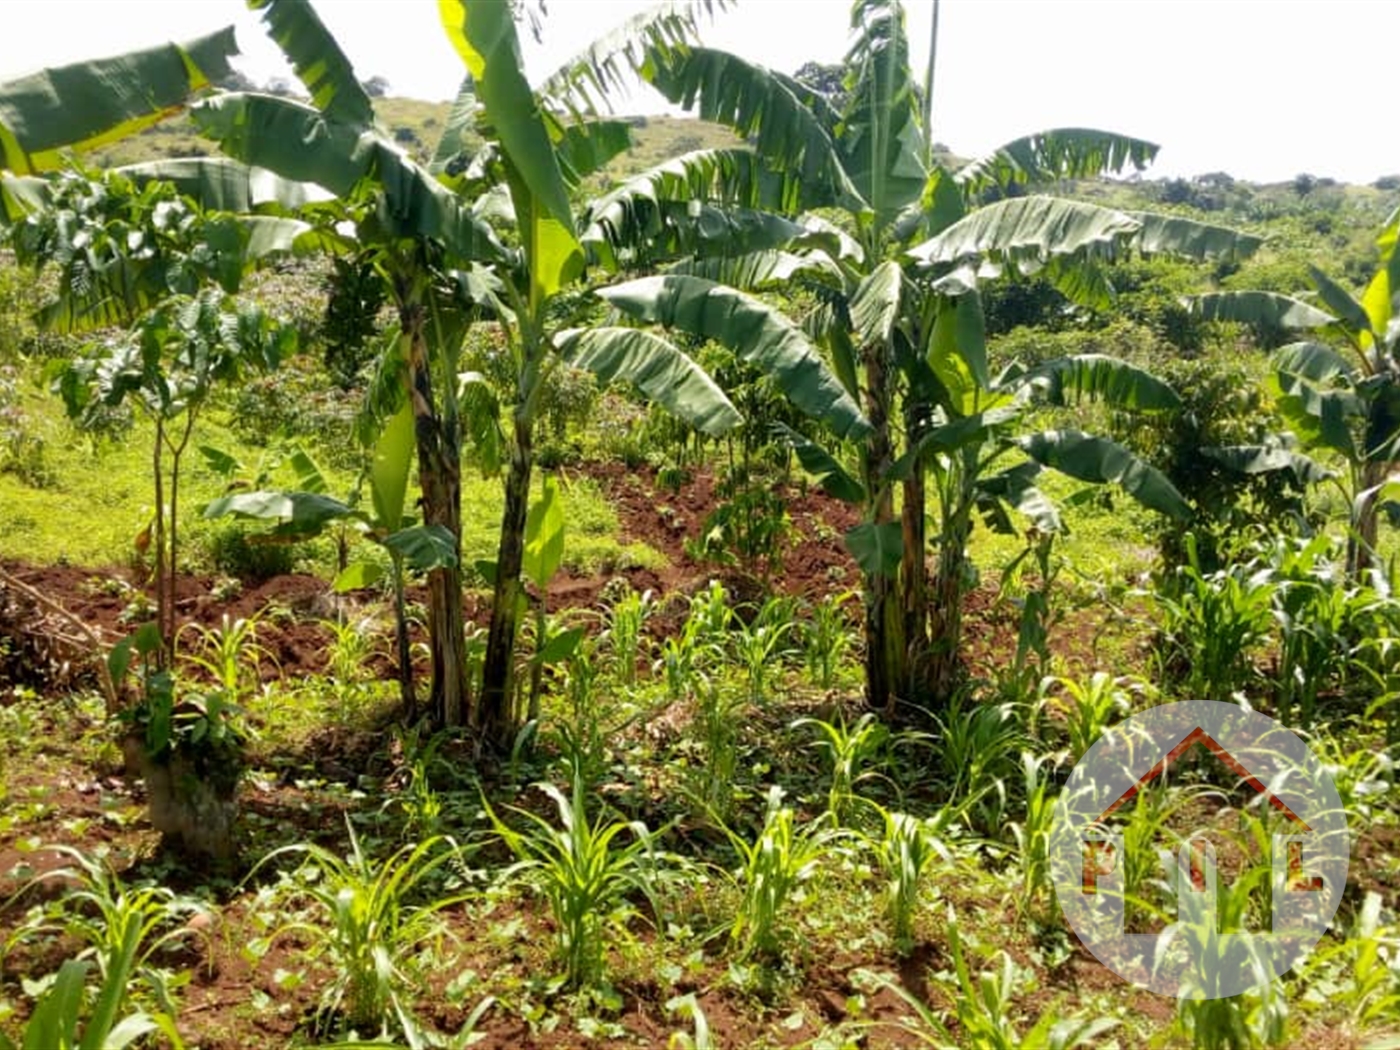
[1189,210,1400,577]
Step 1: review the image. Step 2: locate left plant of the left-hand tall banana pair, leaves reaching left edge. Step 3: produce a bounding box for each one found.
[0,8,504,724]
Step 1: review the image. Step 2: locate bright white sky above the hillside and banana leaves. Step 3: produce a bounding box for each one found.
[0,0,1400,183]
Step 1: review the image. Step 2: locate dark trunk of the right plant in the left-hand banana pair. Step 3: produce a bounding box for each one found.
[479,412,535,748]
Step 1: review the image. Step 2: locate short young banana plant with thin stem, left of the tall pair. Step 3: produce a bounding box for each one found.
[204,405,458,721]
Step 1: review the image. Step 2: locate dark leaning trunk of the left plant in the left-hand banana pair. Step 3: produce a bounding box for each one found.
[400,304,469,728]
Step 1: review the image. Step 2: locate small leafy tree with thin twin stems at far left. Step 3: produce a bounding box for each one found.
[10,172,296,662]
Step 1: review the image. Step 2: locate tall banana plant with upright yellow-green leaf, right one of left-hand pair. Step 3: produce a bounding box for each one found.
[425,0,864,741]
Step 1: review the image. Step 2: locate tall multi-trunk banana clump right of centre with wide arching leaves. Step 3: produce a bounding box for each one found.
[610,0,1257,707]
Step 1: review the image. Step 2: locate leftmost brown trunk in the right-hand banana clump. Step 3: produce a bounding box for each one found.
[862,344,909,715]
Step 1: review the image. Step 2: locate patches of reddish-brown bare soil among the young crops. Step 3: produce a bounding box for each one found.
[0,465,1332,1050]
